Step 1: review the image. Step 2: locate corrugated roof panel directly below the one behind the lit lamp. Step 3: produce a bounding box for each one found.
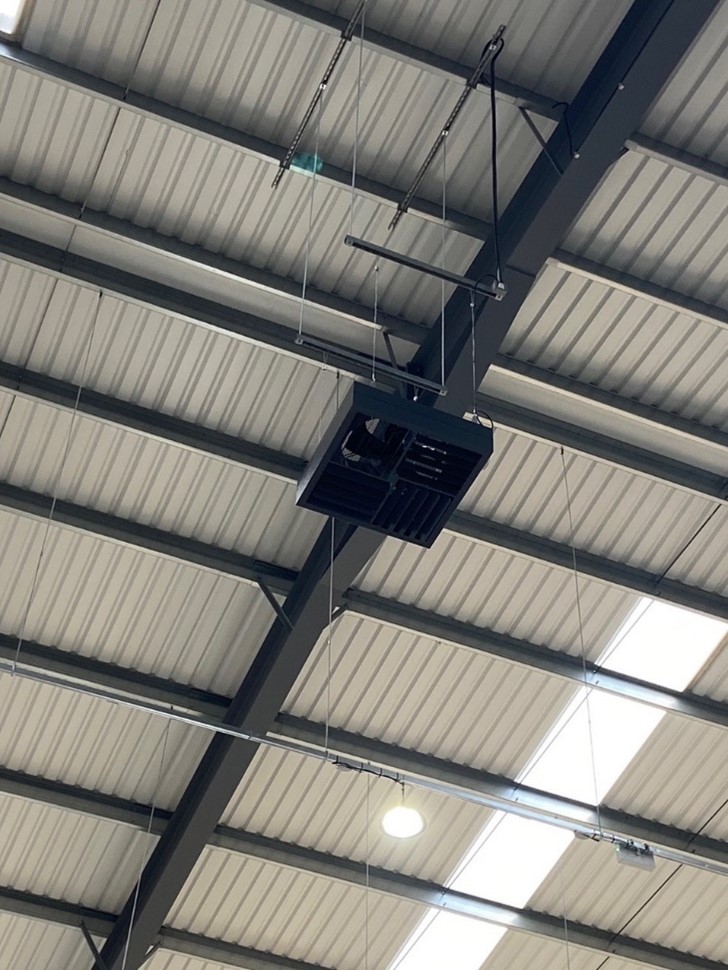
[169,849,424,970]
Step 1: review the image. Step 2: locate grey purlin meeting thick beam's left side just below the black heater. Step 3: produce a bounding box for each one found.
[0,483,297,594]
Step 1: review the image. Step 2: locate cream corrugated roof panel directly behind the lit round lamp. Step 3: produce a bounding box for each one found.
[222,748,490,883]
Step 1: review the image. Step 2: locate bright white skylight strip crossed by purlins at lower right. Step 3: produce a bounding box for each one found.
[392,599,728,970]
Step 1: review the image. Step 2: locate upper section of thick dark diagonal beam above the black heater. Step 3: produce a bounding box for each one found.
[413,0,715,400]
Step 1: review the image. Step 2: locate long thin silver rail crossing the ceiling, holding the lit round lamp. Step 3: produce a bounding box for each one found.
[0,661,728,876]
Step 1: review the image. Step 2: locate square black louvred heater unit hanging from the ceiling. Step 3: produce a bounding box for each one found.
[296,384,493,546]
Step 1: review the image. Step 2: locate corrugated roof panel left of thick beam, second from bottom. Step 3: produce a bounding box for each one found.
[0,795,148,912]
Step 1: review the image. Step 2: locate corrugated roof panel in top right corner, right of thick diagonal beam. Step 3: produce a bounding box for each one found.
[642,3,728,165]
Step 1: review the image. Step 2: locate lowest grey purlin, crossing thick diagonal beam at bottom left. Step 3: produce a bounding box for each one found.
[0,887,326,970]
